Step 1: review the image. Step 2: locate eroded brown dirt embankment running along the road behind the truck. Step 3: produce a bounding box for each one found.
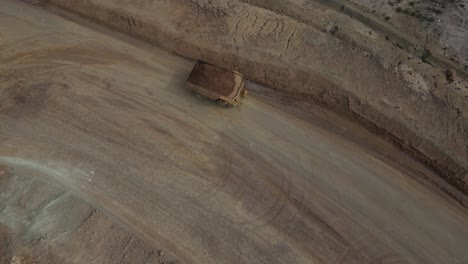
[42,0,468,200]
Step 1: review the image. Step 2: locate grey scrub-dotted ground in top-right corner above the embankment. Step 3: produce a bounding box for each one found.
[351,0,468,66]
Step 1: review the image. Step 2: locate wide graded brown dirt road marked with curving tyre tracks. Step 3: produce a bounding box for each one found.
[0,0,468,264]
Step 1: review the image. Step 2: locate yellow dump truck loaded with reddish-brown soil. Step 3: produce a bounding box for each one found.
[185,61,247,107]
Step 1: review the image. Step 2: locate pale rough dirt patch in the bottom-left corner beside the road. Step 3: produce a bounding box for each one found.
[0,168,177,264]
